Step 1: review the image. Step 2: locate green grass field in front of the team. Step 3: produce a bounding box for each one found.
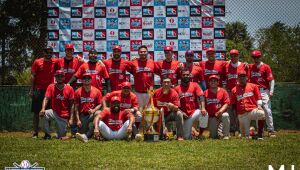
[0,131,300,170]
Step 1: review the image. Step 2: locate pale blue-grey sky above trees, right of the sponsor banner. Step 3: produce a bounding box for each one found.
[225,0,300,35]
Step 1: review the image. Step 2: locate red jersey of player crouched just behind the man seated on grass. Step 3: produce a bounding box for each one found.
[105,90,139,110]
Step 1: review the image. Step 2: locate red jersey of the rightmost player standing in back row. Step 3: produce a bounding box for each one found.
[249,62,274,90]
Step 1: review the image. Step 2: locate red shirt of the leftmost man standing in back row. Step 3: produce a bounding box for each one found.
[31,58,57,90]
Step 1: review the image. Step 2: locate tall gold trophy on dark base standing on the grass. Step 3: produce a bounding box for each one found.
[142,87,161,142]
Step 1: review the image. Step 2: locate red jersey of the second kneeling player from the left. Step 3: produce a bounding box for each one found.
[74,86,102,114]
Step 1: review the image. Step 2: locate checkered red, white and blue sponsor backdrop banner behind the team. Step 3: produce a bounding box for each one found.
[48,0,226,62]
